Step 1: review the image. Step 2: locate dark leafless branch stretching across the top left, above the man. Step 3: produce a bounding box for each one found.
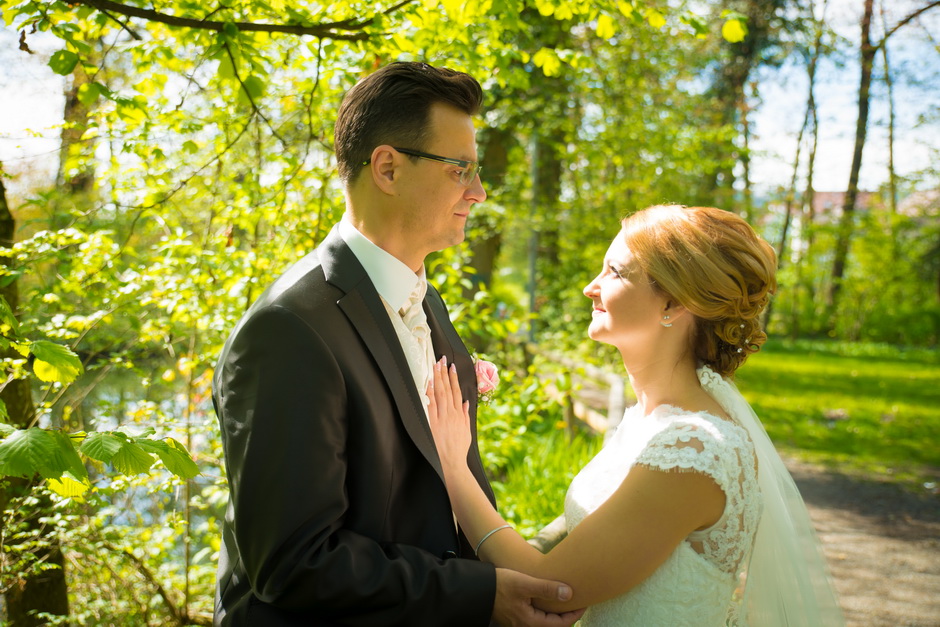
[77,0,414,41]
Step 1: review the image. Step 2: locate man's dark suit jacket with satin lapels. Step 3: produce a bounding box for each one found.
[213,228,496,627]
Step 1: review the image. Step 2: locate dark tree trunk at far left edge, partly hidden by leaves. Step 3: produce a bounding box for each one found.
[0,167,69,627]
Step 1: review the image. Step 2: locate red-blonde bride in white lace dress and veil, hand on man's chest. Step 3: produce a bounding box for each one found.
[428,205,842,627]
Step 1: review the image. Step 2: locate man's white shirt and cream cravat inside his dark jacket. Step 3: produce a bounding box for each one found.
[339,216,434,414]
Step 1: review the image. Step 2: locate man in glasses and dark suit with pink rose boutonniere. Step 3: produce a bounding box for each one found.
[213,63,577,627]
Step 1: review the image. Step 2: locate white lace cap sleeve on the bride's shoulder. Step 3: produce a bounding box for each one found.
[636,417,731,494]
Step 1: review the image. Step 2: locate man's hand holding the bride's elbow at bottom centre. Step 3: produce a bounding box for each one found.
[493,568,584,627]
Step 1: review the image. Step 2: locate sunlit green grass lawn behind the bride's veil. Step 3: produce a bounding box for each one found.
[737,341,940,483]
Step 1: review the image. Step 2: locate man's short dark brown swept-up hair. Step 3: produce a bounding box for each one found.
[334,62,483,184]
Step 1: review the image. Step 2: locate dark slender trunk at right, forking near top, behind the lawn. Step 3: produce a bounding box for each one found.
[826,0,877,324]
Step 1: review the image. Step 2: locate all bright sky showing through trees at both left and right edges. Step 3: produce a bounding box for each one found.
[0,0,940,201]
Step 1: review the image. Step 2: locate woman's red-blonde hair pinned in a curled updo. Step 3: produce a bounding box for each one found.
[622,205,777,376]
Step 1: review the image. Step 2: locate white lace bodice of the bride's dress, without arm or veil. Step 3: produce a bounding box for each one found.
[565,372,761,627]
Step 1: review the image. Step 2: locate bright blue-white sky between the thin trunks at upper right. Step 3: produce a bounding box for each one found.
[752,0,940,191]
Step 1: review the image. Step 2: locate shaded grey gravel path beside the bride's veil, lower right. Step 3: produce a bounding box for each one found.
[786,459,940,627]
